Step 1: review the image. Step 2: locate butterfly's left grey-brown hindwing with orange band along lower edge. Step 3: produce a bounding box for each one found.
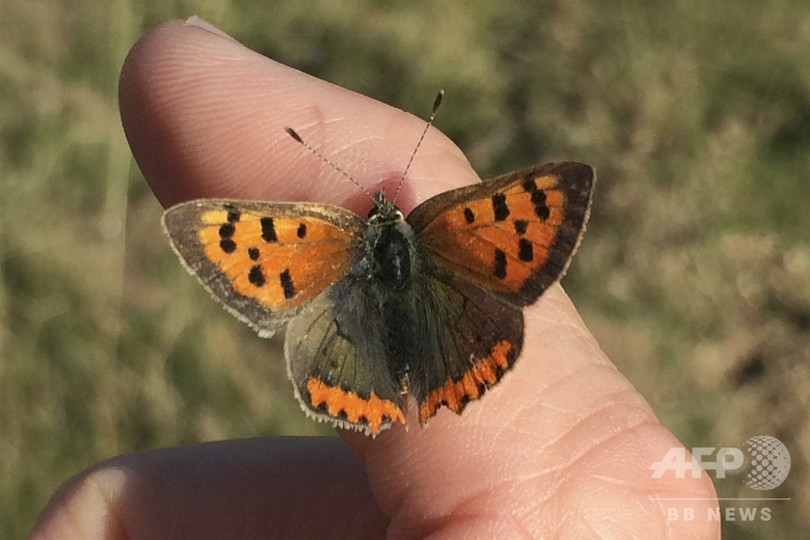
[284,273,405,434]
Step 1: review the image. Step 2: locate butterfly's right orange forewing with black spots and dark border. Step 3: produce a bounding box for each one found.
[408,162,594,306]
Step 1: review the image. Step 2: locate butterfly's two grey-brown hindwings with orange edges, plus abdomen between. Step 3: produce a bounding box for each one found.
[285,249,523,433]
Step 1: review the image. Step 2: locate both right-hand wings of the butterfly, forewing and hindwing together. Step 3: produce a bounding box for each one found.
[407,163,594,422]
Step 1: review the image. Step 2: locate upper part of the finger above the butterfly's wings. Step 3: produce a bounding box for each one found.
[119,20,477,211]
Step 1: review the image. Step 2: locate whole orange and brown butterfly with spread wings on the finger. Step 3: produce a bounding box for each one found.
[163,96,595,435]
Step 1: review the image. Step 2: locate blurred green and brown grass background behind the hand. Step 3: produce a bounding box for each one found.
[0,0,810,538]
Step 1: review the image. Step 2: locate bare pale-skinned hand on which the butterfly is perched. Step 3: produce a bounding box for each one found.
[31,20,720,539]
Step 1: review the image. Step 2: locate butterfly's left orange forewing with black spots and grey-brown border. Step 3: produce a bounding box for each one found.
[163,199,365,337]
